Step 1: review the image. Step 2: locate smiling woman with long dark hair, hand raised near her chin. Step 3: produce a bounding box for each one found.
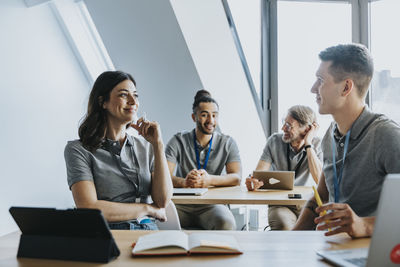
[64,71,172,229]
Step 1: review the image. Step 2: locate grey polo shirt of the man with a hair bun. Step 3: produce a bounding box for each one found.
[165,129,240,178]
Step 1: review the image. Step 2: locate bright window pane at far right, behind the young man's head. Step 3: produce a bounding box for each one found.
[371,0,400,123]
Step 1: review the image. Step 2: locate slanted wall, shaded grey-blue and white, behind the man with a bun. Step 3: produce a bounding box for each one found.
[85,0,265,180]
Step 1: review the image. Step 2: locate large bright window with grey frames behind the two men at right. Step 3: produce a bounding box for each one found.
[222,0,400,136]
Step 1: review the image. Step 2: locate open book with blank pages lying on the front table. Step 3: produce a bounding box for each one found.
[132,231,242,256]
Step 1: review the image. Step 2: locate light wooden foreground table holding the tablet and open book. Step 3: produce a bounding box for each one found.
[0,230,370,267]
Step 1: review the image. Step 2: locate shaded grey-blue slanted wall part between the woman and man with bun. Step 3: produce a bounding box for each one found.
[85,0,203,142]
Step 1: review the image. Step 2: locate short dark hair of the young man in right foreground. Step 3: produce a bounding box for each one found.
[319,44,374,97]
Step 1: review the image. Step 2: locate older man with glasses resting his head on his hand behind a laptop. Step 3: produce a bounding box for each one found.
[246,105,322,230]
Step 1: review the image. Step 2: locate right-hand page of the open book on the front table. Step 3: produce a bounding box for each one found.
[189,233,240,253]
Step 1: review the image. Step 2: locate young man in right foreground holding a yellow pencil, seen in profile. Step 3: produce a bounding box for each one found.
[294,44,400,237]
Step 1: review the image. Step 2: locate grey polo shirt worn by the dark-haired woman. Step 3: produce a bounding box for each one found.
[64,135,153,203]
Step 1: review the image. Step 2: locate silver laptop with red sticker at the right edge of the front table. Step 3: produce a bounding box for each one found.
[317,174,400,267]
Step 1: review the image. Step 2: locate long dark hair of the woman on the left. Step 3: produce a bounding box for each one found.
[79,71,136,152]
